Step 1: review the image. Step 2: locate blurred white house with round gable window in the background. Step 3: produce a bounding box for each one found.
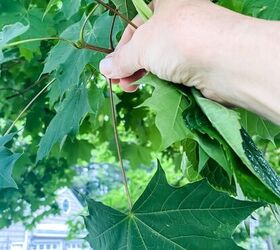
[0,188,90,250]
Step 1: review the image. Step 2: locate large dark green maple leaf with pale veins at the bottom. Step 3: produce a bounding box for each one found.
[85,163,262,250]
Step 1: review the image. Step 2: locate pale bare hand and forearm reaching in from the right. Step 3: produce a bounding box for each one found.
[100,0,280,125]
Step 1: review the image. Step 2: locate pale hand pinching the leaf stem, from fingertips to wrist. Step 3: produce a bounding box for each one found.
[100,0,245,101]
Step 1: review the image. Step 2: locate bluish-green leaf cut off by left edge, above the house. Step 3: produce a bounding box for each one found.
[0,134,21,190]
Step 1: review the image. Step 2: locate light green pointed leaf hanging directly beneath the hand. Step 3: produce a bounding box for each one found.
[138,74,192,150]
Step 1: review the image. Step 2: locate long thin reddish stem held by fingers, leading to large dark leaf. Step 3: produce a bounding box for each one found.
[109,15,132,210]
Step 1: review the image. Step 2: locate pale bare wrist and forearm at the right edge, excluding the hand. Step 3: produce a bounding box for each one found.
[207,16,280,124]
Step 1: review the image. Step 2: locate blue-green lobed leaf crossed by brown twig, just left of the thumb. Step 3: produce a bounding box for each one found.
[42,13,122,103]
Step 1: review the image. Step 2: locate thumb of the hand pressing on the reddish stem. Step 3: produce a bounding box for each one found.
[99,39,141,79]
